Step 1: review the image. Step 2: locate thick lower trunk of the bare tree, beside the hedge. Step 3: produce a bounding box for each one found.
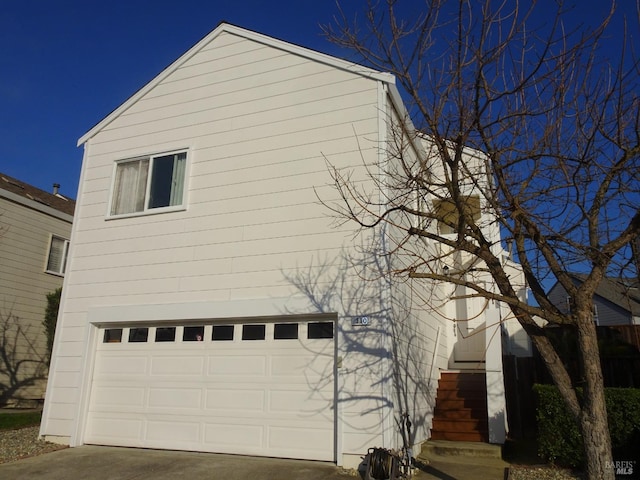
[577,314,615,480]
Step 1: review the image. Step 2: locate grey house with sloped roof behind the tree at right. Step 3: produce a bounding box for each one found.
[549,273,640,327]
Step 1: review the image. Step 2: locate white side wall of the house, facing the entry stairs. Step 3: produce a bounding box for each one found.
[380,99,451,455]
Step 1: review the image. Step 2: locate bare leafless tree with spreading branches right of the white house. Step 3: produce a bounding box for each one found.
[324,0,640,479]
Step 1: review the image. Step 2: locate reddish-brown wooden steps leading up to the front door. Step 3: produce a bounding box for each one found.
[431,372,489,442]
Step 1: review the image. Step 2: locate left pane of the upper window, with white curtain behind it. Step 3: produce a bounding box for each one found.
[111,159,149,215]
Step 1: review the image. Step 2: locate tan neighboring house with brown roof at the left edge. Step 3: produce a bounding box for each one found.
[0,173,75,406]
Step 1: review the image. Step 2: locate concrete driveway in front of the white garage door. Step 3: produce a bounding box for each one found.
[0,445,360,480]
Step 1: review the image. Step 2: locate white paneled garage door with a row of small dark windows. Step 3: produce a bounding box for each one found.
[85,320,335,461]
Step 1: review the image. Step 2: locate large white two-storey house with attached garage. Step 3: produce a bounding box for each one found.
[40,23,515,466]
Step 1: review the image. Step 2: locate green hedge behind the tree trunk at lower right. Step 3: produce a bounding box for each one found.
[533,385,640,468]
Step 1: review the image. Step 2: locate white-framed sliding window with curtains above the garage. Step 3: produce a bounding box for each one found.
[111,152,187,215]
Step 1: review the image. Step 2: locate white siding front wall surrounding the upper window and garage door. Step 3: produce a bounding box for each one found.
[41,26,396,463]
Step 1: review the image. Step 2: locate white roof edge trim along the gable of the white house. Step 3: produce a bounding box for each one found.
[78,22,400,146]
